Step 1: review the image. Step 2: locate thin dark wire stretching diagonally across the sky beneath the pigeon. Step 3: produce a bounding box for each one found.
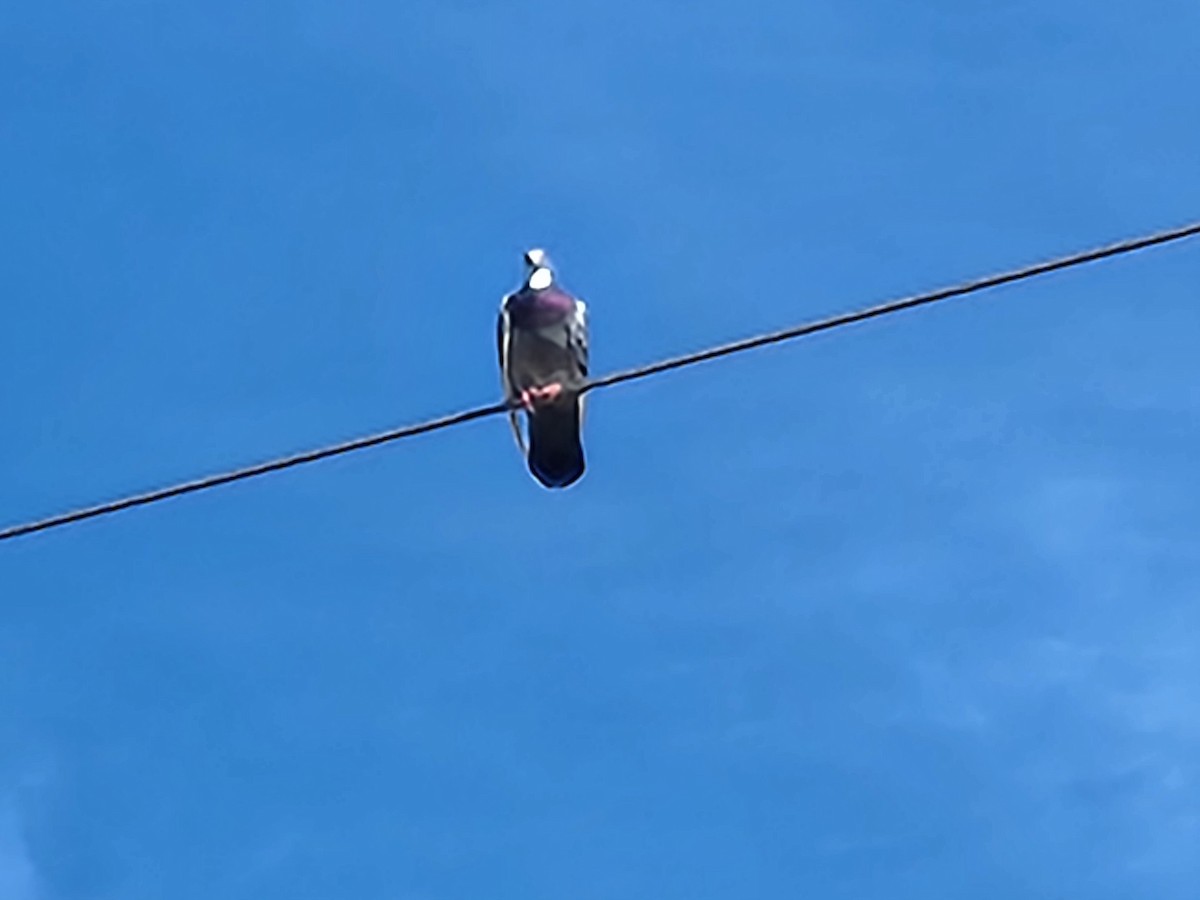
[0,222,1200,541]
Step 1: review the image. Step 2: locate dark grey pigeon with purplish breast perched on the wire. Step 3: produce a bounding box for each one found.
[497,250,588,487]
